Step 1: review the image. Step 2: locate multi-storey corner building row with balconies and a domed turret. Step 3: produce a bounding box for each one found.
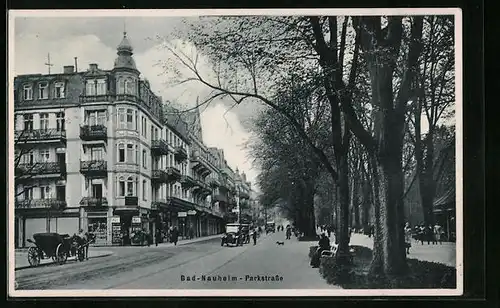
[14,33,250,247]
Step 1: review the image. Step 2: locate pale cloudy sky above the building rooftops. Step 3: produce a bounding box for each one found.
[12,17,258,189]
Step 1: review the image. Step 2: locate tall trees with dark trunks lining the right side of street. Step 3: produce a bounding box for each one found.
[158,16,455,278]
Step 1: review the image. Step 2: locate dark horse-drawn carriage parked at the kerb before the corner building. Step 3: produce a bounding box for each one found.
[28,233,91,266]
